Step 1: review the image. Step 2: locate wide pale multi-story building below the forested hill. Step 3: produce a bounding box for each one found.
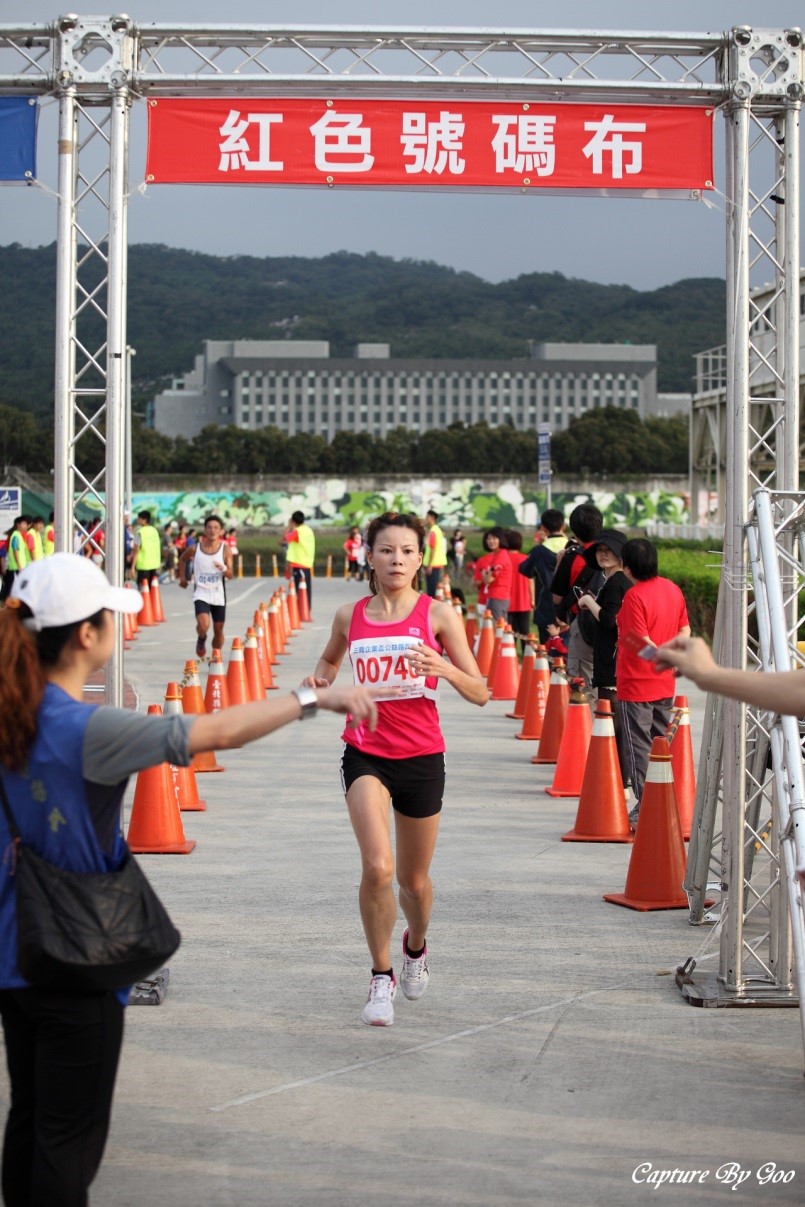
[150,339,661,441]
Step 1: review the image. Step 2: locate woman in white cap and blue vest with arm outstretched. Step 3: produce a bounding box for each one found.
[0,553,377,1207]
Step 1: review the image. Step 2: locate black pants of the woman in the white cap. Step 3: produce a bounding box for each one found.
[0,989,123,1207]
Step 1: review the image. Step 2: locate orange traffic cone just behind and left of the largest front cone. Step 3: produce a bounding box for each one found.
[562,700,634,842]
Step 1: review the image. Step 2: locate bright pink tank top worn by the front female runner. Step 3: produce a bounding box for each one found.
[343,595,444,758]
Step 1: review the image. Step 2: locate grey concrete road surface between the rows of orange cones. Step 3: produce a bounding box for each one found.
[31,579,805,1207]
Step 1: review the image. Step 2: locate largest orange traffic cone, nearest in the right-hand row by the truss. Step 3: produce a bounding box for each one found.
[603,737,688,910]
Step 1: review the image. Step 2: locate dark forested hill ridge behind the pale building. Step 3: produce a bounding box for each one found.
[0,244,725,412]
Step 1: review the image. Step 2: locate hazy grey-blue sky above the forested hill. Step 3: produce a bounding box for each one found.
[0,0,805,290]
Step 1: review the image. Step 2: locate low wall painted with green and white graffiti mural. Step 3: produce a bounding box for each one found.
[127,478,689,529]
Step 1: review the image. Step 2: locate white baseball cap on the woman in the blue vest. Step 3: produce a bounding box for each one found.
[11,553,142,632]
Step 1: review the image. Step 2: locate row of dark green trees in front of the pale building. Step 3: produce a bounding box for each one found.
[0,406,688,476]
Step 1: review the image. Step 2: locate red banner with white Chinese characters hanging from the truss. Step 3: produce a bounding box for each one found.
[146,98,713,192]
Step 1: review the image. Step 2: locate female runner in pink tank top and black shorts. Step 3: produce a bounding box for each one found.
[305,512,489,1027]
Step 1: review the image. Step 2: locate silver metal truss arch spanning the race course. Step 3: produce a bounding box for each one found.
[0,16,805,1057]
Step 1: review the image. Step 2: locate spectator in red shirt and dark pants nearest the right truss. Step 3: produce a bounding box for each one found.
[616,537,690,827]
